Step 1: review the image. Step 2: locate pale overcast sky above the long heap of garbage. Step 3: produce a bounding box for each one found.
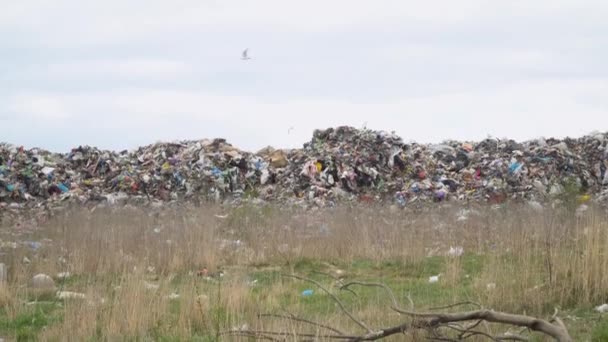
[0,0,608,152]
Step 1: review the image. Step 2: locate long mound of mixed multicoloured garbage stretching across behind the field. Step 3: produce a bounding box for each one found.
[0,126,608,216]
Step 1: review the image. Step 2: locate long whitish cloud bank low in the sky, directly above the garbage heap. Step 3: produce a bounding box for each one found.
[3,80,608,150]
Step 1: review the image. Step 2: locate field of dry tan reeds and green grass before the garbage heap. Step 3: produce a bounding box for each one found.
[0,205,608,341]
